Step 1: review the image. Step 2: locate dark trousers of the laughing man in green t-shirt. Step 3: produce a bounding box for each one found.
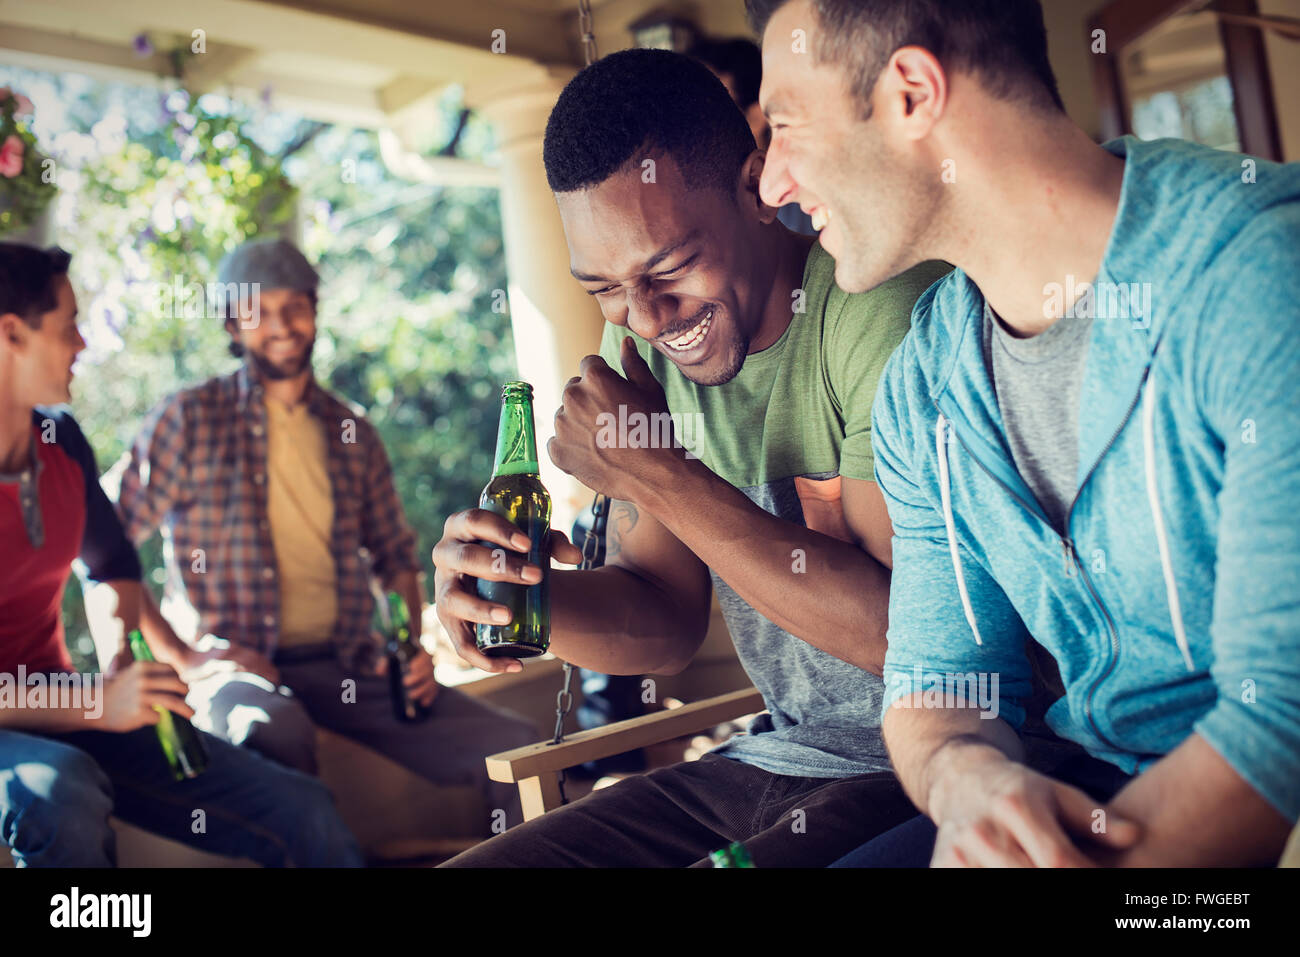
[443,754,917,867]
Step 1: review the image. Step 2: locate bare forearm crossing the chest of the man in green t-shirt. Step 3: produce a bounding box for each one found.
[637,462,889,675]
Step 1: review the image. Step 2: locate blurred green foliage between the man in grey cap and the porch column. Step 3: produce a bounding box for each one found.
[303,123,516,535]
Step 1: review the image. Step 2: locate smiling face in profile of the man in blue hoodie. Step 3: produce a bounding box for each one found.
[759,0,941,293]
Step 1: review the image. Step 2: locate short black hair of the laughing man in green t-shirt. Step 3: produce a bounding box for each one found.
[542,49,758,195]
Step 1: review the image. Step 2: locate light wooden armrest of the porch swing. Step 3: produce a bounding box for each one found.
[488,688,766,783]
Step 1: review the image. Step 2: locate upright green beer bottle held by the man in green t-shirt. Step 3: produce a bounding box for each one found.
[475,382,551,658]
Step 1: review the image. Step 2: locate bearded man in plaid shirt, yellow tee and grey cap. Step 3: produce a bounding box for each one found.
[104,241,538,827]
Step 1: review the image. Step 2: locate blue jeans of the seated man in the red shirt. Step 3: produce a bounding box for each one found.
[0,727,363,867]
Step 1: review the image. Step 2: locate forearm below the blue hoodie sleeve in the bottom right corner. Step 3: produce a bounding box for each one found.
[1104,735,1291,867]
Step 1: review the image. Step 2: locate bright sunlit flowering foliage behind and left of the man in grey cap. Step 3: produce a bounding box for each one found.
[66,94,298,462]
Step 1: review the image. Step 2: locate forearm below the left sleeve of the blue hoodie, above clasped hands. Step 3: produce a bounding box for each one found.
[881,692,1024,823]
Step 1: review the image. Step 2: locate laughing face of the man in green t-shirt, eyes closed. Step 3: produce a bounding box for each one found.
[555,155,775,385]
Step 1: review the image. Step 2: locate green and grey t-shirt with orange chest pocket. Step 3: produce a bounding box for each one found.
[601,244,952,778]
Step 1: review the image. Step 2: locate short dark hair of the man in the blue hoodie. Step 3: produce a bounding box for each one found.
[745,0,1065,116]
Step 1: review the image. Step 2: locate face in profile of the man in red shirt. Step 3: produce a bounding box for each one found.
[0,276,86,406]
